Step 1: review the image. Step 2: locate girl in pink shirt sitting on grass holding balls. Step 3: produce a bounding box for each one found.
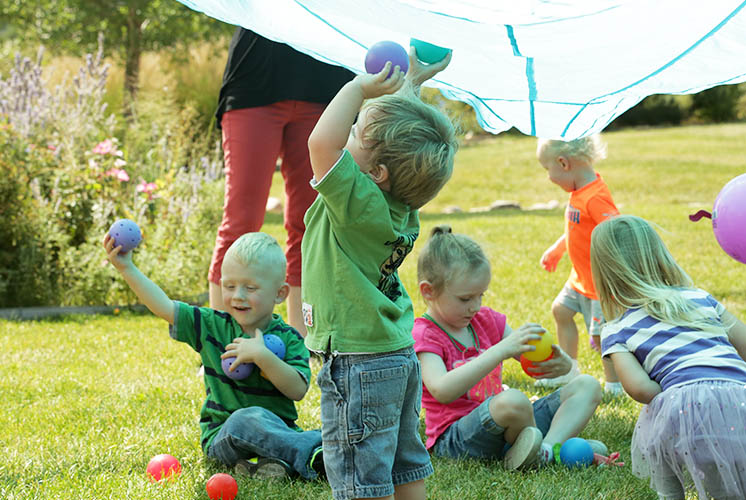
[413,226,608,469]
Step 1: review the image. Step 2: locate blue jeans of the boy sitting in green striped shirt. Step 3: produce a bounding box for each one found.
[207,406,321,479]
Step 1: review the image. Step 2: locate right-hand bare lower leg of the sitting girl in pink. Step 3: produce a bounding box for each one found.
[543,375,601,447]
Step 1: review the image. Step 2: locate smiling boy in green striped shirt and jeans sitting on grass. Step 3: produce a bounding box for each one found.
[104,233,323,479]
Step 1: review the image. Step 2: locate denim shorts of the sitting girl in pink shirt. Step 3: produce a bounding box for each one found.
[433,389,561,459]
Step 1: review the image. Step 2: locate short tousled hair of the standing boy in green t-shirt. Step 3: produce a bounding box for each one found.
[363,95,458,209]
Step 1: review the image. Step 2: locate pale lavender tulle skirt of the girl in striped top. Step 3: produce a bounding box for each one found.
[631,381,746,499]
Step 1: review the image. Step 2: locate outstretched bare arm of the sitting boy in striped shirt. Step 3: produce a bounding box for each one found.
[104,234,174,325]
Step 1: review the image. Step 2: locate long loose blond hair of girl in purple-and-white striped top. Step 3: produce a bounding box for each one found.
[591,215,718,331]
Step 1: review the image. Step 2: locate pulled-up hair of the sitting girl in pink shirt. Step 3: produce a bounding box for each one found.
[417,225,490,295]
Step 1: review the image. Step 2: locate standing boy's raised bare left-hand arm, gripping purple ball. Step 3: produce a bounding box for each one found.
[308,62,404,180]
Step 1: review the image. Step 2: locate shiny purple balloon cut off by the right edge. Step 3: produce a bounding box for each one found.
[712,174,746,264]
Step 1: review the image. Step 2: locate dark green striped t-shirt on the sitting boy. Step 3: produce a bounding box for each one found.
[169,301,311,453]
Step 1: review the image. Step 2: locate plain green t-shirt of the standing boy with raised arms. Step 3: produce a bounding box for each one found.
[301,151,420,353]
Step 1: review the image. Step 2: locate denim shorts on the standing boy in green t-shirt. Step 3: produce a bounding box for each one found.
[317,347,433,500]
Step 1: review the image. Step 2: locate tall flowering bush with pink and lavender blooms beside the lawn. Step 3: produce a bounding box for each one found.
[0,40,223,307]
